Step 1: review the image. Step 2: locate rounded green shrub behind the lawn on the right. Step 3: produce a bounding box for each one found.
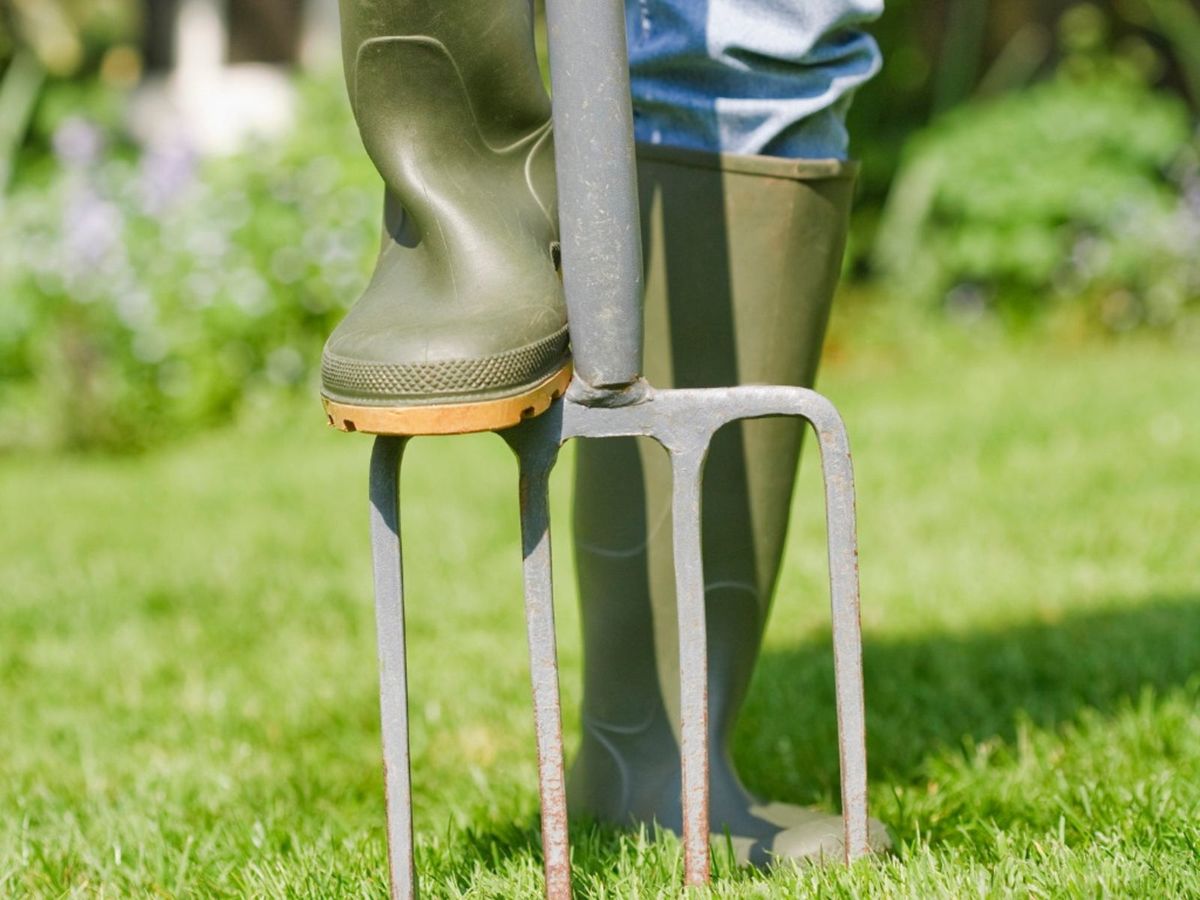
[874,71,1200,330]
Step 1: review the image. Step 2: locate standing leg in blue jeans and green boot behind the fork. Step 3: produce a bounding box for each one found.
[570,0,886,863]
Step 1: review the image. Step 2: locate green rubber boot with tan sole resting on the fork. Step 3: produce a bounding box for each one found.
[322,0,570,433]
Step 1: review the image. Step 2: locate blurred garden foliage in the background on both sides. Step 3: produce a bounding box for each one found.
[0,0,1200,449]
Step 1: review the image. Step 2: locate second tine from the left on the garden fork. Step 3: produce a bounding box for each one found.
[505,422,571,900]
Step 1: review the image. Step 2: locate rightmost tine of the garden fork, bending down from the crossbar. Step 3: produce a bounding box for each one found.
[809,397,870,863]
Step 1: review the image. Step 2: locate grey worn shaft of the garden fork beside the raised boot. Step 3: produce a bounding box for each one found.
[546,0,642,402]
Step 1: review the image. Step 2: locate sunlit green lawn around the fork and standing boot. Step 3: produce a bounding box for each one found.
[0,341,1200,898]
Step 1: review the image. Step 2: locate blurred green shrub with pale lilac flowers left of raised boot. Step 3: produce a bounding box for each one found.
[0,83,379,448]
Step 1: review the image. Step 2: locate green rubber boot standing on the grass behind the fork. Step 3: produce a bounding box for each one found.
[569,146,887,865]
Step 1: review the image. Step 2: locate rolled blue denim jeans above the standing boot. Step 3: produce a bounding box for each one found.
[625,0,883,158]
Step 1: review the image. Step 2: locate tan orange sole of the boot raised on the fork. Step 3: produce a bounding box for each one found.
[320,362,571,437]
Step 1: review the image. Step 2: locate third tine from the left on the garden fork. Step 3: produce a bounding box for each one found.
[671,444,709,886]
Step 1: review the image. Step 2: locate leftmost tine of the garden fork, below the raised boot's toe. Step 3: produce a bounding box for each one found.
[370,437,416,900]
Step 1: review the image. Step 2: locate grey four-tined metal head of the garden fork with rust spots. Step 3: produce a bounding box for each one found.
[371,385,868,900]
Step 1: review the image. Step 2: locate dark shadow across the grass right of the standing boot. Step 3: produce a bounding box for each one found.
[734,594,1200,800]
